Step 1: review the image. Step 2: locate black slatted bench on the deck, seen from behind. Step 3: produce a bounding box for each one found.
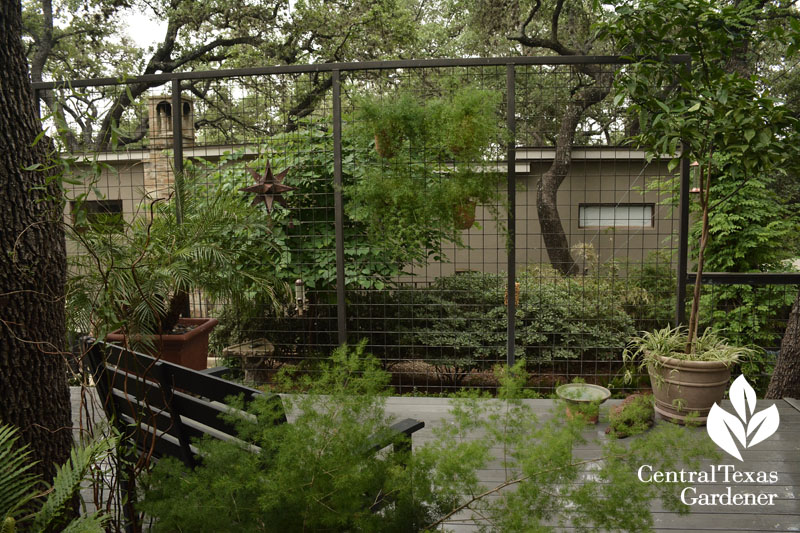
[85,339,425,527]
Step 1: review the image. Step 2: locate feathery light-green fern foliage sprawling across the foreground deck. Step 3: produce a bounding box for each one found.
[142,345,714,532]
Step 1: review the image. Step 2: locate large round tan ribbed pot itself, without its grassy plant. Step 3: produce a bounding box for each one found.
[647,356,731,425]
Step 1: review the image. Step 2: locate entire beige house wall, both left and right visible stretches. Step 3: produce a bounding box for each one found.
[66,147,677,282]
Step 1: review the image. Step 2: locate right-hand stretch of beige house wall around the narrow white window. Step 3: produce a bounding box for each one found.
[404,150,678,282]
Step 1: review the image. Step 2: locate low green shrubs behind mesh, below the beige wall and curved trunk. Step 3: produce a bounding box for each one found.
[364,267,635,383]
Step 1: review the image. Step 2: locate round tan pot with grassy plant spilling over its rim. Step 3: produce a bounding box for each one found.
[623,327,753,424]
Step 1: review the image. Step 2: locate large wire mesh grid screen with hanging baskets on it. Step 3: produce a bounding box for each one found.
[43,60,793,393]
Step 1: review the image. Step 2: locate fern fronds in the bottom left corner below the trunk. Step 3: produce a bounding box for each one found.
[0,426,116,533]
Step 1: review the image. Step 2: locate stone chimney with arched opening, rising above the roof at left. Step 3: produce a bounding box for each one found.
[144,95,194,199]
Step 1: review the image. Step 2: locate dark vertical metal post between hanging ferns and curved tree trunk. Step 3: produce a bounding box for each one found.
[506,64,517,366]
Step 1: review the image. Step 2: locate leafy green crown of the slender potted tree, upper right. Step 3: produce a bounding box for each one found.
[605,0,794,171]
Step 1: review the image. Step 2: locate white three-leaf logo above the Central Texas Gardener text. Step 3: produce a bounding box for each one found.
[706,375,781,461]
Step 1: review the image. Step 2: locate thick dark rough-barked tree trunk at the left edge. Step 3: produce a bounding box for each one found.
[0,0,72,481]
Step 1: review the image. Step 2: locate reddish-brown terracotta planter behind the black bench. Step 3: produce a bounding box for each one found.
[106,318,219,370]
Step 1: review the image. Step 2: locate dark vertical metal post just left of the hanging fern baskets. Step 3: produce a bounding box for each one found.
[332,70,347,344]
